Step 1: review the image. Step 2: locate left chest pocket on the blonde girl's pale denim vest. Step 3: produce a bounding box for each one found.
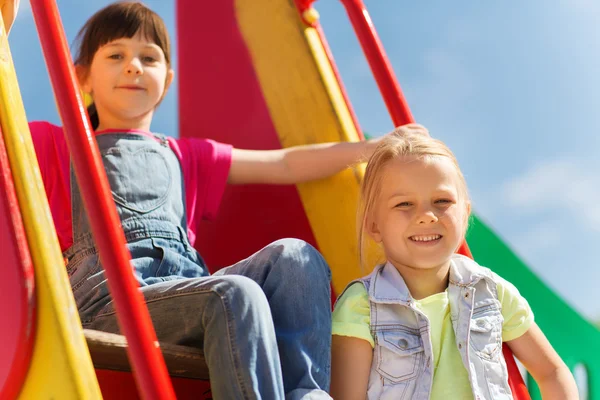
[376,331,424,383]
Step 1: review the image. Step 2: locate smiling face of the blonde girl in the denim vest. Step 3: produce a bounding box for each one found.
[366,156,470,272]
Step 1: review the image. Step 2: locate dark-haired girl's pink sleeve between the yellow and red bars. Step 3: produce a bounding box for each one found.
[29,122,73,251]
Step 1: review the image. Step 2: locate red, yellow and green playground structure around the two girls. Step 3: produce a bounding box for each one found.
[0,0,600,399]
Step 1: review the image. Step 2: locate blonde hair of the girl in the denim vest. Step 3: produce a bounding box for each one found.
[357,124,470,269]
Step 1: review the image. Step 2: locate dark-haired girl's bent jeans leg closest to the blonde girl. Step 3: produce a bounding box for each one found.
[213,239,331,399]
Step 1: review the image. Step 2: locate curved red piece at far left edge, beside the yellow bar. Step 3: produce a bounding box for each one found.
[0,126,36,400]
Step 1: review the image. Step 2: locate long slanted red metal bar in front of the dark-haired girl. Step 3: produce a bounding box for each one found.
[31,0,175,399]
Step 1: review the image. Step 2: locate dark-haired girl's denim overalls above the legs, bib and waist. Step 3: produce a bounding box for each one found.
[64,133,207,323]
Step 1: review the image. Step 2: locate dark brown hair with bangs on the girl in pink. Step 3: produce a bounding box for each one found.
[75,1,171,129]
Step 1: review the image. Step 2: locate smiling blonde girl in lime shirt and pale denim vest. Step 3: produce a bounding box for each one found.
[331,127,578,400]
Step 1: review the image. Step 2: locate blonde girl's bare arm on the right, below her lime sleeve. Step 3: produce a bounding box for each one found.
[506,323,579,400]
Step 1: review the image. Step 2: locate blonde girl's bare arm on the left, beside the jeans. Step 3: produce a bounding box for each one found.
[330,335,373,400]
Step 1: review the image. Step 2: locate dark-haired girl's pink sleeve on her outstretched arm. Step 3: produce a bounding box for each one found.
[169,139,232,245]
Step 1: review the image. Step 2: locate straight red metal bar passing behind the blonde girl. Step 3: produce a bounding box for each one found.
[340,0,530,400]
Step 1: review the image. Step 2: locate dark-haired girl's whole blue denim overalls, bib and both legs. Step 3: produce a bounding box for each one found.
[65,134,331,399]
